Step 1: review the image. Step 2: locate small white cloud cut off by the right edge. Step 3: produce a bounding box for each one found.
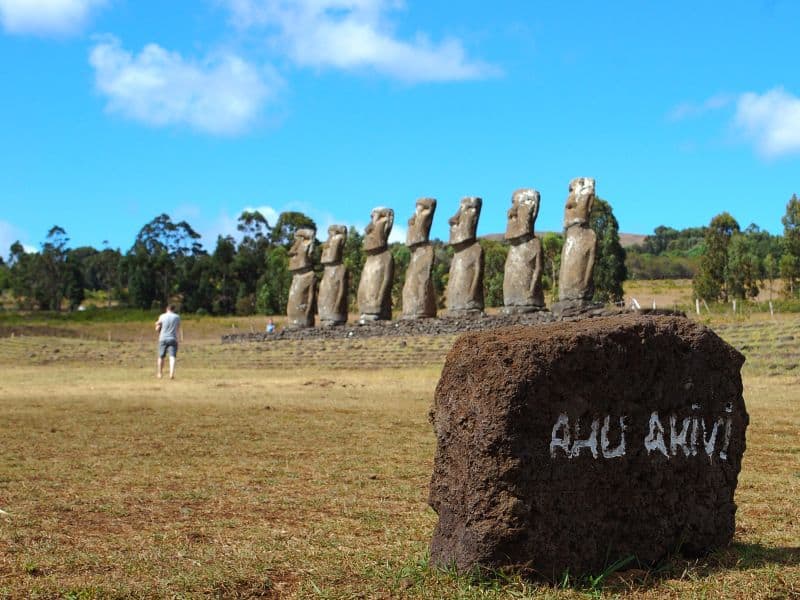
[734,87,800,157]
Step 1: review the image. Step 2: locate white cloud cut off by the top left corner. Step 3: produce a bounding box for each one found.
[0,0,107,35]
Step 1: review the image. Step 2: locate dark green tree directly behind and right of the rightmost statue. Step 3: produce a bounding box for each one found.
[589,198,628,302]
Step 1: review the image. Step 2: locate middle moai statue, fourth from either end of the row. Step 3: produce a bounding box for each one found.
[402,198,436,319]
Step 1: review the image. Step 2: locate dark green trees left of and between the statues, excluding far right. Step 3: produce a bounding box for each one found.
[0,198,627,315]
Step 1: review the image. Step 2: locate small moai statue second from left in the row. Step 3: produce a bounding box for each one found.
[317,225,347,327]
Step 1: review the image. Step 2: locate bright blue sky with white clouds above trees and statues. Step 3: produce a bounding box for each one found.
[0,0,800,257]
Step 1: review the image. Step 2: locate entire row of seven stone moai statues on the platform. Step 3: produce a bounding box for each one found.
[287,177,597,328]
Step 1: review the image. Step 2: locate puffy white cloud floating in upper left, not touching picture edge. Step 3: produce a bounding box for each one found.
[89,37,281,135]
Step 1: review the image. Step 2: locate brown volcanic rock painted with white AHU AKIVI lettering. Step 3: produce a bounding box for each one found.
[429,315,748,578]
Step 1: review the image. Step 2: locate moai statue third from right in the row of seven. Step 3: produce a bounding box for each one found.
[440,198,484,317]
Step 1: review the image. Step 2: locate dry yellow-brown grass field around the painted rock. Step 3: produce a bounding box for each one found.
[0,316,800,599]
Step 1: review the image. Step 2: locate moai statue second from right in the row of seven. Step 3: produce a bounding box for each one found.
[503,189,544,314]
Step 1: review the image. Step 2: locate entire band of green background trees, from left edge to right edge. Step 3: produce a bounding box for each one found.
[6,202,800,315]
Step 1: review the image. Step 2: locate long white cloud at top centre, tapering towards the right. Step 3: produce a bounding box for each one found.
[221,0,499,83]
